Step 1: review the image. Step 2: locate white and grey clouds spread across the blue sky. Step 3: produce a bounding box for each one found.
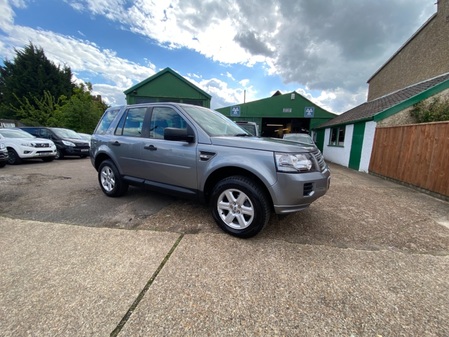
[0,0,436,112]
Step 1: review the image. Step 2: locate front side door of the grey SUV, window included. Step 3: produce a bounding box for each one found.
[139,106,197,194]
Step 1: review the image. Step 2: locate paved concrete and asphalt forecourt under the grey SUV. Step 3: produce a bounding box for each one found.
[0,159,449,336]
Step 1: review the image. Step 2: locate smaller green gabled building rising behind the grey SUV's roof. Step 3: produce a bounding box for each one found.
[124,68,211,108]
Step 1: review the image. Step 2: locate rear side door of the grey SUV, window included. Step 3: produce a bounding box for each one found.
[110,107,148,178]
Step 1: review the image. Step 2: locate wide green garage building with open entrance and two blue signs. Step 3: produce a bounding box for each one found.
[217,91,336,138]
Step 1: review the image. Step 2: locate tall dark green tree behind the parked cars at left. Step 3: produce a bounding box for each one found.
[0,43,74,119]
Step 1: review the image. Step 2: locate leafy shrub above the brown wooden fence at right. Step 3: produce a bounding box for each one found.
[411,97,449,123]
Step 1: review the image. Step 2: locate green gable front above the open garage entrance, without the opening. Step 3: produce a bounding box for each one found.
[216,91,335,120]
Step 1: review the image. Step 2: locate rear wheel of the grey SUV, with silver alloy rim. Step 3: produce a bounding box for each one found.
[98,160,128,197]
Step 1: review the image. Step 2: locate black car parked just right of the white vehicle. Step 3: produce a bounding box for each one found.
[21,126,90,159]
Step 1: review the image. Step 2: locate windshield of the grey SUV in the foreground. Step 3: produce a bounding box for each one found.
[182,106,250,137]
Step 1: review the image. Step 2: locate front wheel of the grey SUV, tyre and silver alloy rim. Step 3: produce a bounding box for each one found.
[211,176,271,238]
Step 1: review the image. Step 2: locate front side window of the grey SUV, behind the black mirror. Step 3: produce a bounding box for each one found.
[149,107,187,139]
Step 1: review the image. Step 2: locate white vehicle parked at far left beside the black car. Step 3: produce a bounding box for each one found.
[0,129,56,165]
